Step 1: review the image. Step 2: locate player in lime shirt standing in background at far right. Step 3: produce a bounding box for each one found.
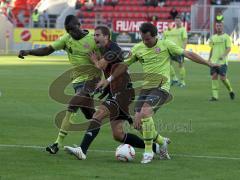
[209,22,235,101]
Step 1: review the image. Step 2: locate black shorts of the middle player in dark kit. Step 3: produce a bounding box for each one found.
[102,88,135,124]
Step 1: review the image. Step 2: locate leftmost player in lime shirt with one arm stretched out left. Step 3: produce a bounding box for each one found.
[19,15,101,154]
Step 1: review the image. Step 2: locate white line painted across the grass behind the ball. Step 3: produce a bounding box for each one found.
[0,144,240,160]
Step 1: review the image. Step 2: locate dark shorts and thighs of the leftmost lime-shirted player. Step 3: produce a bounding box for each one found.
[68,78,100,119]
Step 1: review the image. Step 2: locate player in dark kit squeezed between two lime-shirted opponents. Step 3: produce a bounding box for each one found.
[64,26,166,160]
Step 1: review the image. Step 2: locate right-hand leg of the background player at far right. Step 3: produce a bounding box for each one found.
[219,64,235,100]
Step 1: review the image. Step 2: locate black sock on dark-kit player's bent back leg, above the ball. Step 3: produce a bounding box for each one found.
[122,133,156,152]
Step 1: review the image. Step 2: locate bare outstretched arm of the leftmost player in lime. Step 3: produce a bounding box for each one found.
[18,46,55,59]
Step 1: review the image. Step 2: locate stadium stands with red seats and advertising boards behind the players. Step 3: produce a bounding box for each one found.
[0,0,240,60]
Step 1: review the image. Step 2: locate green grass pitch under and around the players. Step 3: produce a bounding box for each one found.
[0,56,240,180]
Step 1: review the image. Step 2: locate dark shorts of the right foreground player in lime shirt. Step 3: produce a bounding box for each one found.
[135,88,172,112]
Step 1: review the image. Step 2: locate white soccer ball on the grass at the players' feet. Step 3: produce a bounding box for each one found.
[115,144,135,162]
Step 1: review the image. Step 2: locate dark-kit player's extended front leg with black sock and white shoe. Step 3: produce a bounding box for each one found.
[64,105,110,160]
